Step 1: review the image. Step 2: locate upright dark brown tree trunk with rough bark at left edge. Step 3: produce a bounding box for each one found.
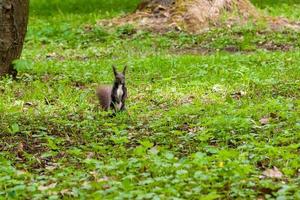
[0,0,29,76]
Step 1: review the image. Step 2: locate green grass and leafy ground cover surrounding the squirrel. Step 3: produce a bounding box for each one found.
[0,0,300,199]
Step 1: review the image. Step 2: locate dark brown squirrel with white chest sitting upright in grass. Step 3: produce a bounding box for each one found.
[96,65,127,112]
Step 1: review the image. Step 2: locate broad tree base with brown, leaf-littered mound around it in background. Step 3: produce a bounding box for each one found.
[101,0,300,33]
